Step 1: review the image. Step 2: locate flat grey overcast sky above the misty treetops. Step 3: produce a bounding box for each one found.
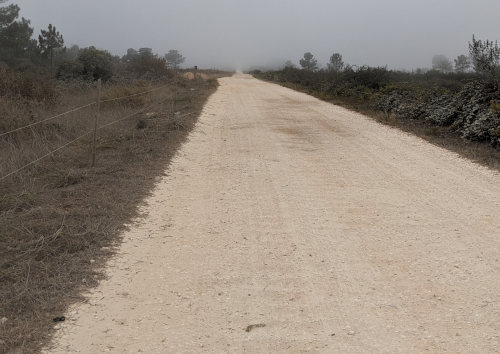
[9,0,500,69]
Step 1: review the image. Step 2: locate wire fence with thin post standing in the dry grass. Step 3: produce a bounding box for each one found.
[0,82,180,182]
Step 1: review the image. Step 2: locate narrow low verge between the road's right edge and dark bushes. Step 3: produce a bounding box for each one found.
[254,72,500,171]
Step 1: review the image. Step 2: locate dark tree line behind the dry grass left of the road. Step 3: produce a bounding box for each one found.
[0,0,185,80]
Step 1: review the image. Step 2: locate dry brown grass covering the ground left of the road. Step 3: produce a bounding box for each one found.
[0,72,223,353]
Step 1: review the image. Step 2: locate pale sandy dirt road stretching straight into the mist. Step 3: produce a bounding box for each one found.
[45,75,500,353]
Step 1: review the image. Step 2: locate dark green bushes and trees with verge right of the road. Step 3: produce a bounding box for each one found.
[252,36,500,168]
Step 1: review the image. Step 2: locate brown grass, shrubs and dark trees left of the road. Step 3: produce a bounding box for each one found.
[0,1,226,353]
